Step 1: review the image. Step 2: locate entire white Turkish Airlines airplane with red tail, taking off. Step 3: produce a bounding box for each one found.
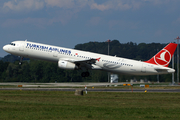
[3,41,177,77]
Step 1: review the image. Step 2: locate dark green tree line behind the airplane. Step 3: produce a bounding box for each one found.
[0,40,179,83]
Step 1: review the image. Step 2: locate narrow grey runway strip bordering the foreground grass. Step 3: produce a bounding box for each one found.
[0,88,180,92]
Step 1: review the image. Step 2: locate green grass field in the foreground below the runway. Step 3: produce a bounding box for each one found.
[0,91,180,120]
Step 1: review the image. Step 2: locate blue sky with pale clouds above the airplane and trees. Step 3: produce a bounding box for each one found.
[0,0,180,57]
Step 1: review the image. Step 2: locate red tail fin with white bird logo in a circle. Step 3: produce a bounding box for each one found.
[146,43,177,67]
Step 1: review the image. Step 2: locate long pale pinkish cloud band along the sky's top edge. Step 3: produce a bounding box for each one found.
[2,0,141,12]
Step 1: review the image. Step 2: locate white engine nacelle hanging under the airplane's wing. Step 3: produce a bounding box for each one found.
[58,60,77,70]
